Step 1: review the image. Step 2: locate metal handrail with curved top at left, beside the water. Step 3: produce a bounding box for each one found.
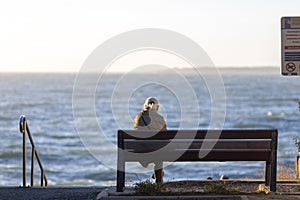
[19,115,48,187]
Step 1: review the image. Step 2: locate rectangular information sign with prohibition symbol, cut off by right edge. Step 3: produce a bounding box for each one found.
[281,17,300,76]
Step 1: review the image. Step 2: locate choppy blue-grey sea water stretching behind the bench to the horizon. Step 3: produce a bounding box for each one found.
[0,71,300,186]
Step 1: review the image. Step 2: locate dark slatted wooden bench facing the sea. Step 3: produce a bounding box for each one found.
[117,129,278,192]
